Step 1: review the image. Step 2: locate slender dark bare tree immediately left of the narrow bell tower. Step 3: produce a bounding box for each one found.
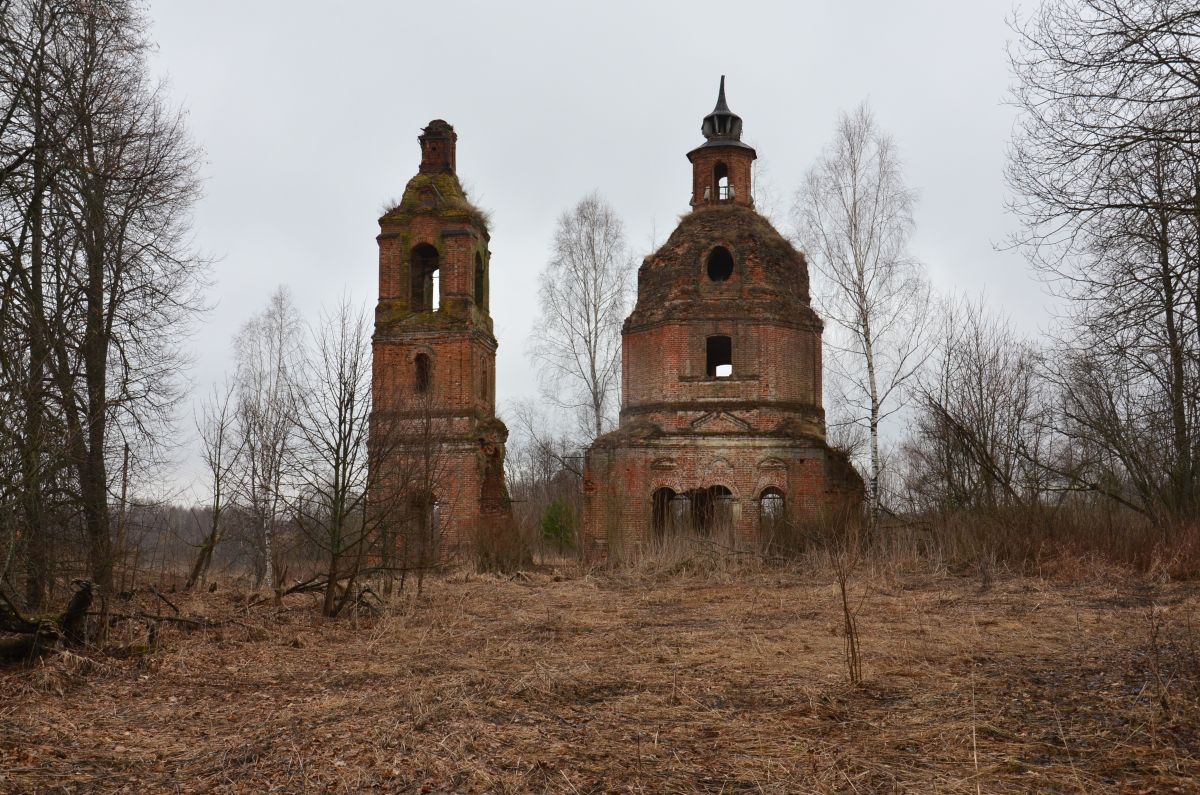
[293,299,378,616]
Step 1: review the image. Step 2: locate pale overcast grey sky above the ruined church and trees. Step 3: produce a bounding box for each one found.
[142,0,1050,499]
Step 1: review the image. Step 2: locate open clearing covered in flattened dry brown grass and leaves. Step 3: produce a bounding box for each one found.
[0,570,1200,794]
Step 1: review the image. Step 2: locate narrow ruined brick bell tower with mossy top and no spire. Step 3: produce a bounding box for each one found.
[371,119,511,564]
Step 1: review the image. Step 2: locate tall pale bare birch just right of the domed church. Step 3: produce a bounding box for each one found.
[794,104,930,526]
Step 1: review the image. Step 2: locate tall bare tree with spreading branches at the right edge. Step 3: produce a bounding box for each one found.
[1008,0,1200,519]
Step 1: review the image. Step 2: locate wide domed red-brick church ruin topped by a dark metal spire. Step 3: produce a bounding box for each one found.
[584,78,863,550]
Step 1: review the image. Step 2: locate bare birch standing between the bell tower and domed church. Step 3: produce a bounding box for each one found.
[529,193,632,440]
